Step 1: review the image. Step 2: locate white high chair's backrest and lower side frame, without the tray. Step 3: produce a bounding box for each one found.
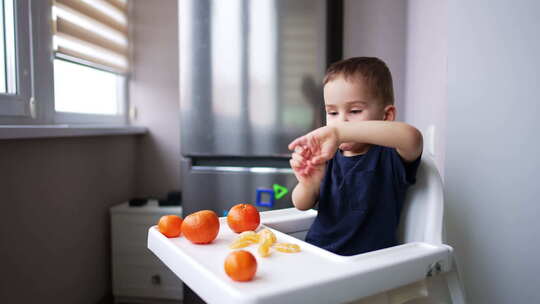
[357,156,465,304]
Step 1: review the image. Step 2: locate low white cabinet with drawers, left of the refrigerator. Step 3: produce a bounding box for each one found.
[110,201,183,303]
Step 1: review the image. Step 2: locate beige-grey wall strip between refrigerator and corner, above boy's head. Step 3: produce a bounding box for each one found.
[343,0,407,119]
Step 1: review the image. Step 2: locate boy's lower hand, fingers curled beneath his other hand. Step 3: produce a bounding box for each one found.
[289,146,326,188]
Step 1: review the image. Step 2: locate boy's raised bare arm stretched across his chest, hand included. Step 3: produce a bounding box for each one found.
[289,120,423,165]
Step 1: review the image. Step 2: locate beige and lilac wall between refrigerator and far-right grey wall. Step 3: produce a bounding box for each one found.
[343,0,448,174]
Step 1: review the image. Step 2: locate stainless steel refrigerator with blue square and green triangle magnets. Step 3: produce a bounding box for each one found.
[179,0,342,216]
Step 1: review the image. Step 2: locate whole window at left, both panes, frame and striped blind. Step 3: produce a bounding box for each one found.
[0,0,129,124]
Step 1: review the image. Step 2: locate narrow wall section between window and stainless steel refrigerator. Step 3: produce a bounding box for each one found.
[130,0,180,197]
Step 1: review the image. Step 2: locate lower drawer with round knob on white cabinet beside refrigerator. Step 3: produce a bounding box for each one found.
[113,263,183,300]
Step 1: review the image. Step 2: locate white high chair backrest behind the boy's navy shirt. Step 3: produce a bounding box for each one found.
[398,155,444,244]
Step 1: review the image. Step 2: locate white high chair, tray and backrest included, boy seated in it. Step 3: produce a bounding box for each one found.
[148,157,465,304]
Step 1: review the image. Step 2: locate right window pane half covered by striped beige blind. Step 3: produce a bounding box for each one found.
[52,0,129,123]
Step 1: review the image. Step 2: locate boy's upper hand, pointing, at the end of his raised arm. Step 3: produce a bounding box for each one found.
[289,126,339,166]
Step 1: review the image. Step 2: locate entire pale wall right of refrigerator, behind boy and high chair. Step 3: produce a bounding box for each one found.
[344,0,540,303]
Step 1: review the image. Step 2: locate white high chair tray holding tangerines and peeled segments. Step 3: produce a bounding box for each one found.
[148,208,452,303]
